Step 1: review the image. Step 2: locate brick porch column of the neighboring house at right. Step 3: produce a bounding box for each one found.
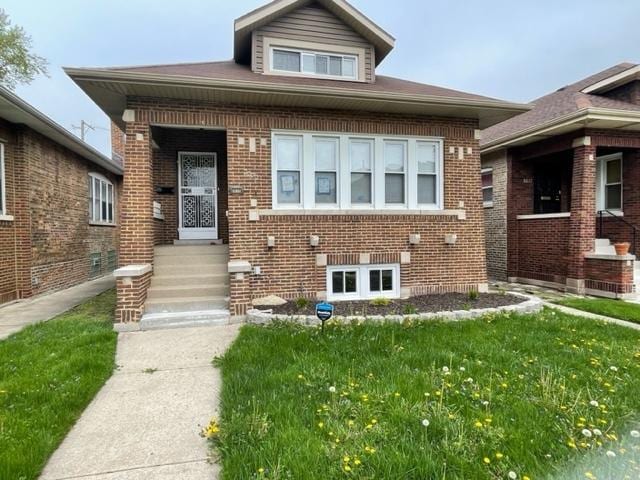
[567,137,596,293]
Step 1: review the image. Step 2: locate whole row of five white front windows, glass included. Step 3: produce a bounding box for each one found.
[271,130,444,211]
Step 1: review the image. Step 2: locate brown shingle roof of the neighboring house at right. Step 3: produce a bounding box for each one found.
[481,63,640,145]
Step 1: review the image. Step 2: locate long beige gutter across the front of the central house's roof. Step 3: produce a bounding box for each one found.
[64,68,532,113]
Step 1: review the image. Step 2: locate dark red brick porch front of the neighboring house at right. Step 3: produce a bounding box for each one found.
[482,129,640,294]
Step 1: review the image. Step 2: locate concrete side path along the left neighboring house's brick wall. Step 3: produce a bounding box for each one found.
[0,275,115,340]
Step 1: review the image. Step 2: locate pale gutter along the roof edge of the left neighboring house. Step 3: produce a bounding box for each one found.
[0,87,124,175]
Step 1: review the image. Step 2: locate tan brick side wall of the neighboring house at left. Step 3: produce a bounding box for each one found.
[0,122,120,302]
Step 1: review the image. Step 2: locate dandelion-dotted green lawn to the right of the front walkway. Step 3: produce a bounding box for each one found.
[218,310,640,480]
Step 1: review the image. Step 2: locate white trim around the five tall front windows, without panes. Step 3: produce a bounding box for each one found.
[271,130,445,212]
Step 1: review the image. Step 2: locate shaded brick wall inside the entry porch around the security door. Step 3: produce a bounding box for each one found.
[152,129,229,245]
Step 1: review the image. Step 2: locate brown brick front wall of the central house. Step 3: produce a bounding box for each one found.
[122,98,486,313]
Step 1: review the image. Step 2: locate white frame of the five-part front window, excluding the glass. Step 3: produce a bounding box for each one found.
[271,130,444,211]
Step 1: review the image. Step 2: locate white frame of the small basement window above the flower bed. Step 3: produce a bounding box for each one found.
[326,263,400,301]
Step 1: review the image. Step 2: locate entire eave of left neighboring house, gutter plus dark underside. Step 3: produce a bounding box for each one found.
[0,86,123,175]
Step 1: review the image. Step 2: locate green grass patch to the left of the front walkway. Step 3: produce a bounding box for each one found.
[0,291,116,480]
